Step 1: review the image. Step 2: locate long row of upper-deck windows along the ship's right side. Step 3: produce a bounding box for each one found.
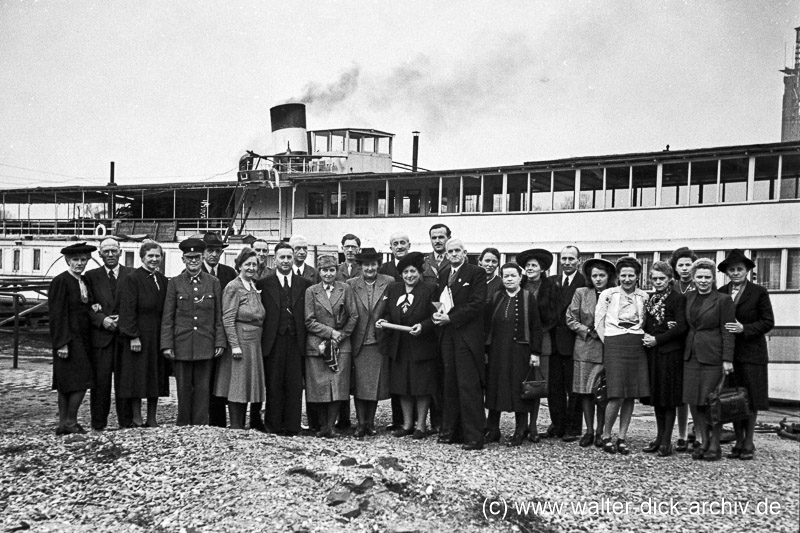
[305,154,800,217]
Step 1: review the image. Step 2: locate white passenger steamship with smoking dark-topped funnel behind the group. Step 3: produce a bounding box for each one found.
[0,103,800,401]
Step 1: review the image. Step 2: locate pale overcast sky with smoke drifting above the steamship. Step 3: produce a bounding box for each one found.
[0,0,800,187]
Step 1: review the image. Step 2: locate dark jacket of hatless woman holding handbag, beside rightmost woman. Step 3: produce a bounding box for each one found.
[683,290,736,366]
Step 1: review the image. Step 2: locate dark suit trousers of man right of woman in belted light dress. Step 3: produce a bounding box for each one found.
[264,335,303,434]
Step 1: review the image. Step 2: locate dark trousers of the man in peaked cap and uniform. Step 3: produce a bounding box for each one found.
[172,359,214,426]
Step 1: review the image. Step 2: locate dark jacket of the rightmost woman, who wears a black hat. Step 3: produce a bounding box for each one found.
[719,281,775,365]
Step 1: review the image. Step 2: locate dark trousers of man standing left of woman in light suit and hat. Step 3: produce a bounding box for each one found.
[547,353,582,437]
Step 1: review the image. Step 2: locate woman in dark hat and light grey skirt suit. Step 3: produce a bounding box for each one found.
[567,259,617,448]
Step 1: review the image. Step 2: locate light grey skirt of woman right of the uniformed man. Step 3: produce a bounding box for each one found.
[214,322,266,403]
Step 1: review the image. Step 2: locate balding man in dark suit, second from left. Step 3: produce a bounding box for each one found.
[84,238,133,430]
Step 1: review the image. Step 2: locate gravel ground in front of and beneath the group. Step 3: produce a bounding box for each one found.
[0,358,800,533]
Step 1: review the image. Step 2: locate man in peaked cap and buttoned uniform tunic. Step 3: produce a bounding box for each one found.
[161,238,227,426]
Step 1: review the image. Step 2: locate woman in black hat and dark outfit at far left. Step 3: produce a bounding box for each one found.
[47,242,97,435]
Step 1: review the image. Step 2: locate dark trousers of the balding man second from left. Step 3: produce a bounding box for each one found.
[89,337,133,429]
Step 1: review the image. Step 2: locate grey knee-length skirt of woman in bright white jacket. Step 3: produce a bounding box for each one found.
[604,333,650,398]
